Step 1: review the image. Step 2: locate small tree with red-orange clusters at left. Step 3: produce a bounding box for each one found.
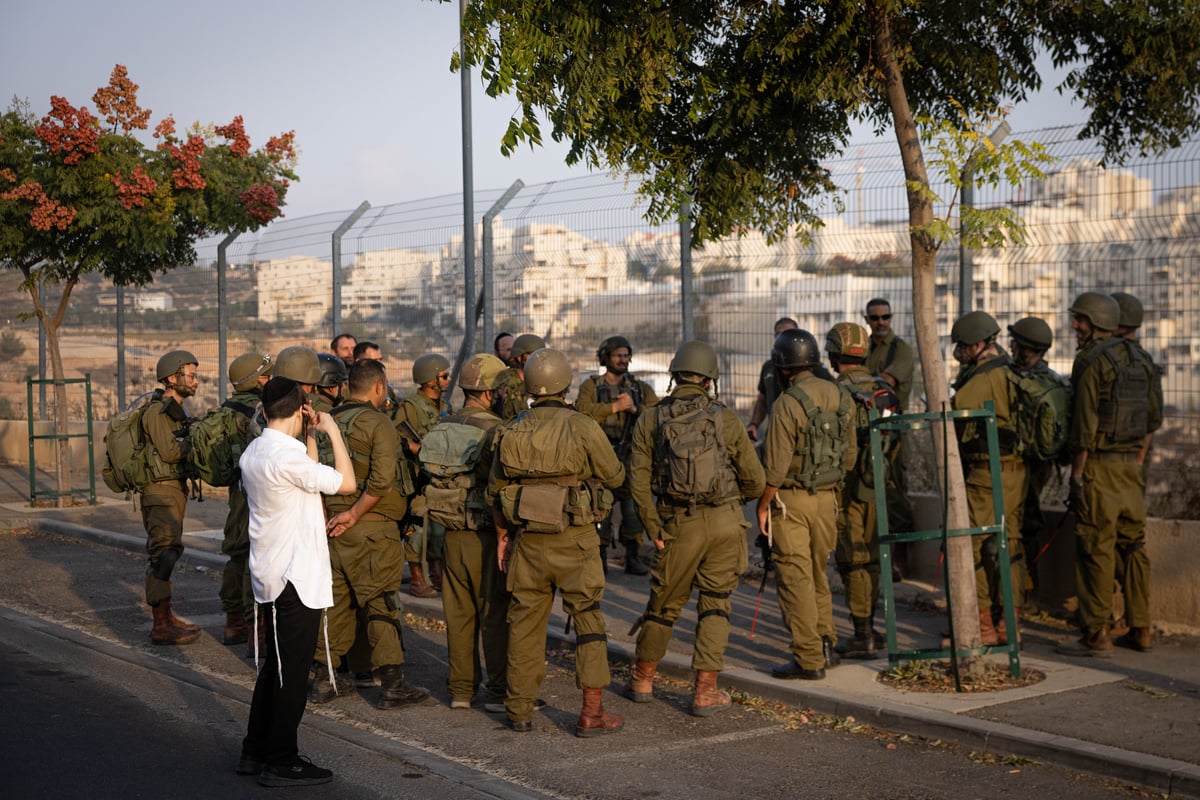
[0,65,295,506]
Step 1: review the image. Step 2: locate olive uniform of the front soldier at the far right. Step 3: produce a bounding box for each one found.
[1068,337,1163,636]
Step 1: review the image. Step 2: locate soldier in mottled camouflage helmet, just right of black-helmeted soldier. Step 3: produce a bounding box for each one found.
[826,323,899,658]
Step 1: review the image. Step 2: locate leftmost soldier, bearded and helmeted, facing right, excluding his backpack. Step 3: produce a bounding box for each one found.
[142,350,200,644]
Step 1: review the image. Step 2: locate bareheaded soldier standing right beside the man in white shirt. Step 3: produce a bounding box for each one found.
[310,359,430,709]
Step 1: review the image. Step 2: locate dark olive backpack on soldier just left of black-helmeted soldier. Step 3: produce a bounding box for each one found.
[654,395,742,511]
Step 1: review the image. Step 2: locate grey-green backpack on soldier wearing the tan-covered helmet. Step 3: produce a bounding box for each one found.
[418,414,499,530]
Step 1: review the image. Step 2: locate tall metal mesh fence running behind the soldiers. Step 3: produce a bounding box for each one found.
[9,127,1200,517]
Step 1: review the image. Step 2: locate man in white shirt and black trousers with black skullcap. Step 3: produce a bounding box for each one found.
[238,378,355,787]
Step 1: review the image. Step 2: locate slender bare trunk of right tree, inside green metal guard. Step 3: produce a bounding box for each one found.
[868,2,983,675]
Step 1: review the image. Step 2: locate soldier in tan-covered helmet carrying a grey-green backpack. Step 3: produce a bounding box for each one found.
[420,355,509,714]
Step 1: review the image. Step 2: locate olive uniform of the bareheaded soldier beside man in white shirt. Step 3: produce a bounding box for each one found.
[316,401,408,669]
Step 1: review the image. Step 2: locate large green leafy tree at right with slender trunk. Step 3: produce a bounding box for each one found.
[451,0,1200,671]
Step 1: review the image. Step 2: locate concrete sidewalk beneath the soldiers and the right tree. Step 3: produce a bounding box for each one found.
[7,464,1200,798]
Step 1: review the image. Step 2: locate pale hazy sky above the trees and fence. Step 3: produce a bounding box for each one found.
[0,0,1084,218]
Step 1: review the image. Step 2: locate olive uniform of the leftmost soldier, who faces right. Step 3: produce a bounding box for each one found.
[142,390,187,606]
